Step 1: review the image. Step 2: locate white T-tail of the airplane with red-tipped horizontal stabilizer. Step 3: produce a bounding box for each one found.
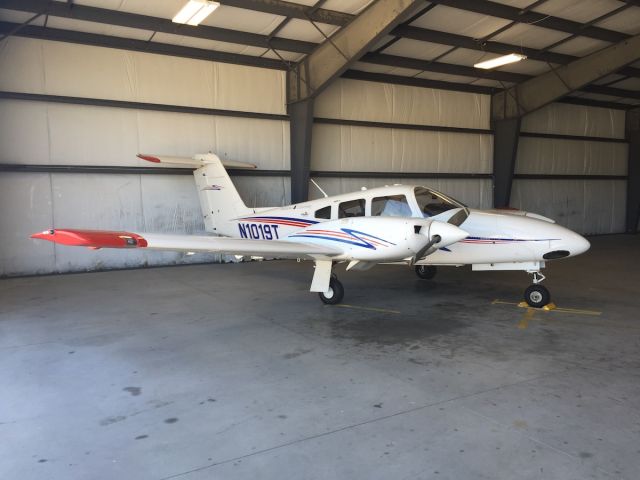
[138,153,256,236]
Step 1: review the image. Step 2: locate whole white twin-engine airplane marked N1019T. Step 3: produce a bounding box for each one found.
[32,153,589,307]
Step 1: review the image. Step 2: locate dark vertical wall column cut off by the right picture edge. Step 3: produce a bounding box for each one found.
[625,109,640,233]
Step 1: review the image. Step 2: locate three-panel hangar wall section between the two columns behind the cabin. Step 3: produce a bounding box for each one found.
[309,79,493,208]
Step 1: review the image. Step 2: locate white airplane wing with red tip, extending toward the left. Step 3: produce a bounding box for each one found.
[31,229,342,260]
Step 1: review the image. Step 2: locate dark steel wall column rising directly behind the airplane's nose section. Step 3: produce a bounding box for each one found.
[492,117,520,208]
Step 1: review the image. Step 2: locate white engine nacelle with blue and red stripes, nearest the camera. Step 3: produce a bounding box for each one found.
[288,217,468,262]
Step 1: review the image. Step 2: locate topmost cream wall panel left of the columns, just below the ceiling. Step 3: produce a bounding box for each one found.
[0,37,285,114]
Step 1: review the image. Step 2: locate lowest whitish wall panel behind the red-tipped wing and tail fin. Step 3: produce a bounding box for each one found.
[0,173,282,276]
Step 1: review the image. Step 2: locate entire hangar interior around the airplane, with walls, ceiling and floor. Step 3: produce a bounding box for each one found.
[0,0,640,479]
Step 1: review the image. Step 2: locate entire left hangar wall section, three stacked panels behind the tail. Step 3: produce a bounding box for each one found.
[0,37,290,275]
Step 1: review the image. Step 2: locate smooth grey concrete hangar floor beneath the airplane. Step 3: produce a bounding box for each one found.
[0,236,640,480]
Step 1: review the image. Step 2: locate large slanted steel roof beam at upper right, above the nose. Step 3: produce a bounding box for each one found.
[491,35,640,120]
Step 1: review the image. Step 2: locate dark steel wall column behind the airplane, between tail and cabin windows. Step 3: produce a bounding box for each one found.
[289,97,313,203]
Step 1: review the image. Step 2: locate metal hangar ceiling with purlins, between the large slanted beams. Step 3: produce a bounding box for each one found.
[0,0,640,108]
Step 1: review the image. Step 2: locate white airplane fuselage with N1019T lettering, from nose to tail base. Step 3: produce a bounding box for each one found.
[224,185,589,270]
